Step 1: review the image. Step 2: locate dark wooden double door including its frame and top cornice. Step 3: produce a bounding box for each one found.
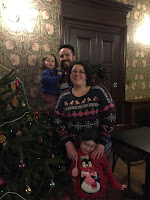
[60,0,132,123]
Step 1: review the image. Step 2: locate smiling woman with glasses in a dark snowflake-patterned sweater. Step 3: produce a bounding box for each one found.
[55,61,116,160]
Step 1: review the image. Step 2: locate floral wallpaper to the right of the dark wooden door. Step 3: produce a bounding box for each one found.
[116,0,150,100]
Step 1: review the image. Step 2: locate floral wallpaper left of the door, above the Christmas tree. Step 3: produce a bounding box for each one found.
[0,0,60,110]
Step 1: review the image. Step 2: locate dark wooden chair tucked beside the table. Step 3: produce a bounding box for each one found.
[112,124,145,193]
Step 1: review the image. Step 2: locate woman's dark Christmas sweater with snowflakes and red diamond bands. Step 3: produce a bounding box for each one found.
[55,84,116,145]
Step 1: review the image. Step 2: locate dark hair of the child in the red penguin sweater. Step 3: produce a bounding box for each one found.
[80,128,100,144]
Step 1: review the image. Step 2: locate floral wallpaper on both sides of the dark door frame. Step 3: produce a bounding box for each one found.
[0,0,150,110]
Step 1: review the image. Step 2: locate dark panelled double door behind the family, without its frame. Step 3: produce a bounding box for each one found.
[66,25,124,122]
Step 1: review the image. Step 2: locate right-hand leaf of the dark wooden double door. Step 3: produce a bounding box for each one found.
[97,32,120,120]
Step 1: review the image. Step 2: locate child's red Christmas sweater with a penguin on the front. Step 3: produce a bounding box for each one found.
[70,149,122,199]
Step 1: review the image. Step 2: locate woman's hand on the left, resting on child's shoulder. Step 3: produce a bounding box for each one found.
[65,141,78,160]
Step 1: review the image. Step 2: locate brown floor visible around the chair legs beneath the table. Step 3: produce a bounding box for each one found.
[108,152,145,200]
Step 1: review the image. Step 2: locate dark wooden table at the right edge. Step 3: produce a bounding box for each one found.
[112,127,150,200]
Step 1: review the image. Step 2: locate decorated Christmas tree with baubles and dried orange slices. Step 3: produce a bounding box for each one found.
[0,71,70,200]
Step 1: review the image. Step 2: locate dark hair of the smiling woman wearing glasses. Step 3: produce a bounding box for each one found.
[68,61,93,86]
